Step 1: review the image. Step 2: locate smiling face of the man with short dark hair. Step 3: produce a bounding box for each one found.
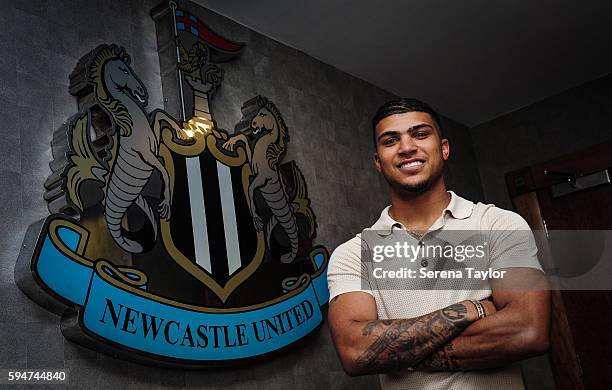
[374,111,449,195]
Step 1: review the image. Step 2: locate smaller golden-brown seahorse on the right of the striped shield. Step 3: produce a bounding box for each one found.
[222,96,298,263]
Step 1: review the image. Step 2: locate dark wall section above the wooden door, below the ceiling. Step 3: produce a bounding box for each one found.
[471,75,612,208]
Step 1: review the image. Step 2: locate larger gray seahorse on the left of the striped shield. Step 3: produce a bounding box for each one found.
[71,45,189,253]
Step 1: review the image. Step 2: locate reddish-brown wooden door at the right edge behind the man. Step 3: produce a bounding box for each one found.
[506,141,612,390]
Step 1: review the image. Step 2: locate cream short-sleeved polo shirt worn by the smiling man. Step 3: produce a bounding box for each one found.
[327,191,541,390]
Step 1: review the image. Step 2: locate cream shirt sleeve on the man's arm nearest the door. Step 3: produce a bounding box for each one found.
[485,207,542,271]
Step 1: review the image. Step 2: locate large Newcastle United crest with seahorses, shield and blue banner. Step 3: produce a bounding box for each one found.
[15,3,328,366]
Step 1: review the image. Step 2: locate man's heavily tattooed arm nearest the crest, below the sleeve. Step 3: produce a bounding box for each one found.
[329,292,494,375]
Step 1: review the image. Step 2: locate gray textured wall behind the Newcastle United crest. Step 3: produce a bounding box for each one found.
[0,0,482,389]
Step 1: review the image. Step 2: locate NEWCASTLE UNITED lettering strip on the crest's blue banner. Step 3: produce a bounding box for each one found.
[99,298,314,348]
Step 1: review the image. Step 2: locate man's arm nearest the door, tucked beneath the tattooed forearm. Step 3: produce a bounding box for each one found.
[415,268,550,371]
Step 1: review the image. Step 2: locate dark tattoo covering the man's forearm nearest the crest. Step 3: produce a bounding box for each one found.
[357,303,471,373]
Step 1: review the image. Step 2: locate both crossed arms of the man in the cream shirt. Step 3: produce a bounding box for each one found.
[329,268,550,375]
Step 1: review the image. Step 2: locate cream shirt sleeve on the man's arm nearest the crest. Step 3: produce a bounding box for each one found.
[327,236,372,301]
